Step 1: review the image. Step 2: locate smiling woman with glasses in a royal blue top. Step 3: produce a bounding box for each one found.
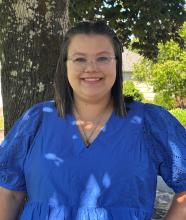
[0,22,186,220]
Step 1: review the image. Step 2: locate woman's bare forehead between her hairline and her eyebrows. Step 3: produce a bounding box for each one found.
[68,34,114,54]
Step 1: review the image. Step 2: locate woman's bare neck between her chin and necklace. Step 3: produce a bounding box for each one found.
[74,97,113,121]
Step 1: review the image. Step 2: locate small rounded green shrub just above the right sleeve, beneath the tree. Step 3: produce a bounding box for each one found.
[154,92,176,110]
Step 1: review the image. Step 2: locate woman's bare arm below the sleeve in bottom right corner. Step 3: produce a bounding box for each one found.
[164,192,186,220]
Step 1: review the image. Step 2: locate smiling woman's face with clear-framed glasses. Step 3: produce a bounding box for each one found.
[67,34,116,101]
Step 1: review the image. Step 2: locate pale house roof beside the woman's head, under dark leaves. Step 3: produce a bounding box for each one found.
[122,48,142,72]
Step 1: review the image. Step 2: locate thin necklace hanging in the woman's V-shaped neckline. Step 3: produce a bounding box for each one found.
[74,102,110,148]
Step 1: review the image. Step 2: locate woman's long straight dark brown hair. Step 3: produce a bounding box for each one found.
[54,21,126,117]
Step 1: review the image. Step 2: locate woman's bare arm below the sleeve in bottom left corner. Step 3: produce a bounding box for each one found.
[0,188,24,220]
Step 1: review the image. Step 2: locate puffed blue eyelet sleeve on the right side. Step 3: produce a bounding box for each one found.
[145,104,186,193]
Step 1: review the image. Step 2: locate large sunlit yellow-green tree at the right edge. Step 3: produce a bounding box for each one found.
[134,23,186,107]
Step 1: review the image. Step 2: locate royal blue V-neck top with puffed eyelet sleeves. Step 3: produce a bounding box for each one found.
[0,101,186,220]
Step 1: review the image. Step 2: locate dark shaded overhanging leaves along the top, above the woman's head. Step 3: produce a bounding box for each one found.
[69,0,186,58]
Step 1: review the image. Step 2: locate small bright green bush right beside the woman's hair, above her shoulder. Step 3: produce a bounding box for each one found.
[123,80,144,101]
